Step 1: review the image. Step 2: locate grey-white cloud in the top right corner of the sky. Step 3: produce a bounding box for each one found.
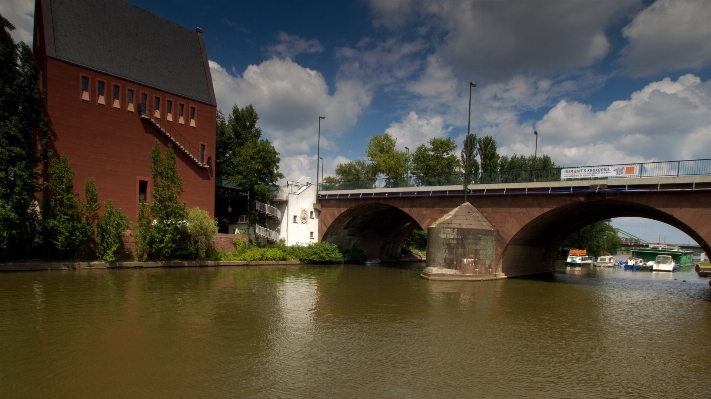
[622,0,711,76]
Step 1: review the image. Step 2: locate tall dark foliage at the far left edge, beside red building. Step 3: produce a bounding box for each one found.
[0,21,50,259]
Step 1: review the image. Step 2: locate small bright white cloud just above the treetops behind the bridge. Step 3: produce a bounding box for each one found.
[385,111,451,152]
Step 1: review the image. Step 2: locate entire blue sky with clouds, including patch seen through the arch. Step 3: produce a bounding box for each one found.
[0,0,711,243]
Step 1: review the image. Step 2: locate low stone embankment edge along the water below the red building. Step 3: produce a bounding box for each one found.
[0,260,303,272]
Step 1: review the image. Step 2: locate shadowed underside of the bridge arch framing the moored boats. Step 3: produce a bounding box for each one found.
[501,198,711,277]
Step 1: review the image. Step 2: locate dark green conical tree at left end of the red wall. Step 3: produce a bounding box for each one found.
[47,155,86,253]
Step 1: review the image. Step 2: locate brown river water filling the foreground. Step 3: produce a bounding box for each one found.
[0,265,711,398]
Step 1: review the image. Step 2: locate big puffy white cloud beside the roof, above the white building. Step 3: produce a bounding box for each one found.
[210,58,372,156]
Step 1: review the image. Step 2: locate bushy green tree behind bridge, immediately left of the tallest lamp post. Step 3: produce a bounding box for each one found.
[412,137,461,186]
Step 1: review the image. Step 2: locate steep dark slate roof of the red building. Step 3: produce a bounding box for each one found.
[50,0,215,105]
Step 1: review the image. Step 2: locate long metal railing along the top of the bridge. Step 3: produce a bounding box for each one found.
[319,159,711,191]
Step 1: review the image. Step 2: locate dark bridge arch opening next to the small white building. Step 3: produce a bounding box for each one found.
[322,202,420,259]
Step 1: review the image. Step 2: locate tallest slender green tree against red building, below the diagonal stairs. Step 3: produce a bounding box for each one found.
[150,140,187,259]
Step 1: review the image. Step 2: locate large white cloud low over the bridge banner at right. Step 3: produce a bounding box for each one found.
[535,74,711,165]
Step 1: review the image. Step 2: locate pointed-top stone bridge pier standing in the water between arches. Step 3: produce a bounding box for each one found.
[421,202,504,280]
